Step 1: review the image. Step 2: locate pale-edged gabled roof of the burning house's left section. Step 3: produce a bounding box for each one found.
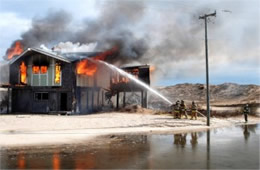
[10,48,99,64]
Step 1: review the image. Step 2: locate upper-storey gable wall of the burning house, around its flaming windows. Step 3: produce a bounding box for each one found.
[10,54,75,88]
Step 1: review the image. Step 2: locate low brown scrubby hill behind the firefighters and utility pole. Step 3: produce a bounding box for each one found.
[149,83,260,108]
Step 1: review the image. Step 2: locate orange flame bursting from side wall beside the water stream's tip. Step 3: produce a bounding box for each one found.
[76,47,117,76]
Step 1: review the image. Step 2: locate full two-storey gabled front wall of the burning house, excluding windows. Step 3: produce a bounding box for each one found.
[10,53,76,113]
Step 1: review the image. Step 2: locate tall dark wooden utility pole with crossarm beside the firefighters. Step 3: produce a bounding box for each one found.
[199,11,217,126]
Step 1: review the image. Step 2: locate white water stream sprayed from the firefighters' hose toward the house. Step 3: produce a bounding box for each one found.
[98,60,172,105]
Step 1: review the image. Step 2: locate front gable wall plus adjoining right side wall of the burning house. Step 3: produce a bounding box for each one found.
[10,52,116,114]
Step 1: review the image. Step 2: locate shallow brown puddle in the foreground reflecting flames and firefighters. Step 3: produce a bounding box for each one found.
[0,124,260,169]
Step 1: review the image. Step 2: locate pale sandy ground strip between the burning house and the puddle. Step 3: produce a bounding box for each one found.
[0,112,260,147]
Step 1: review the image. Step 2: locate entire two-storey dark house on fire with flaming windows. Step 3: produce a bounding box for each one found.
[3,48,150,114]
